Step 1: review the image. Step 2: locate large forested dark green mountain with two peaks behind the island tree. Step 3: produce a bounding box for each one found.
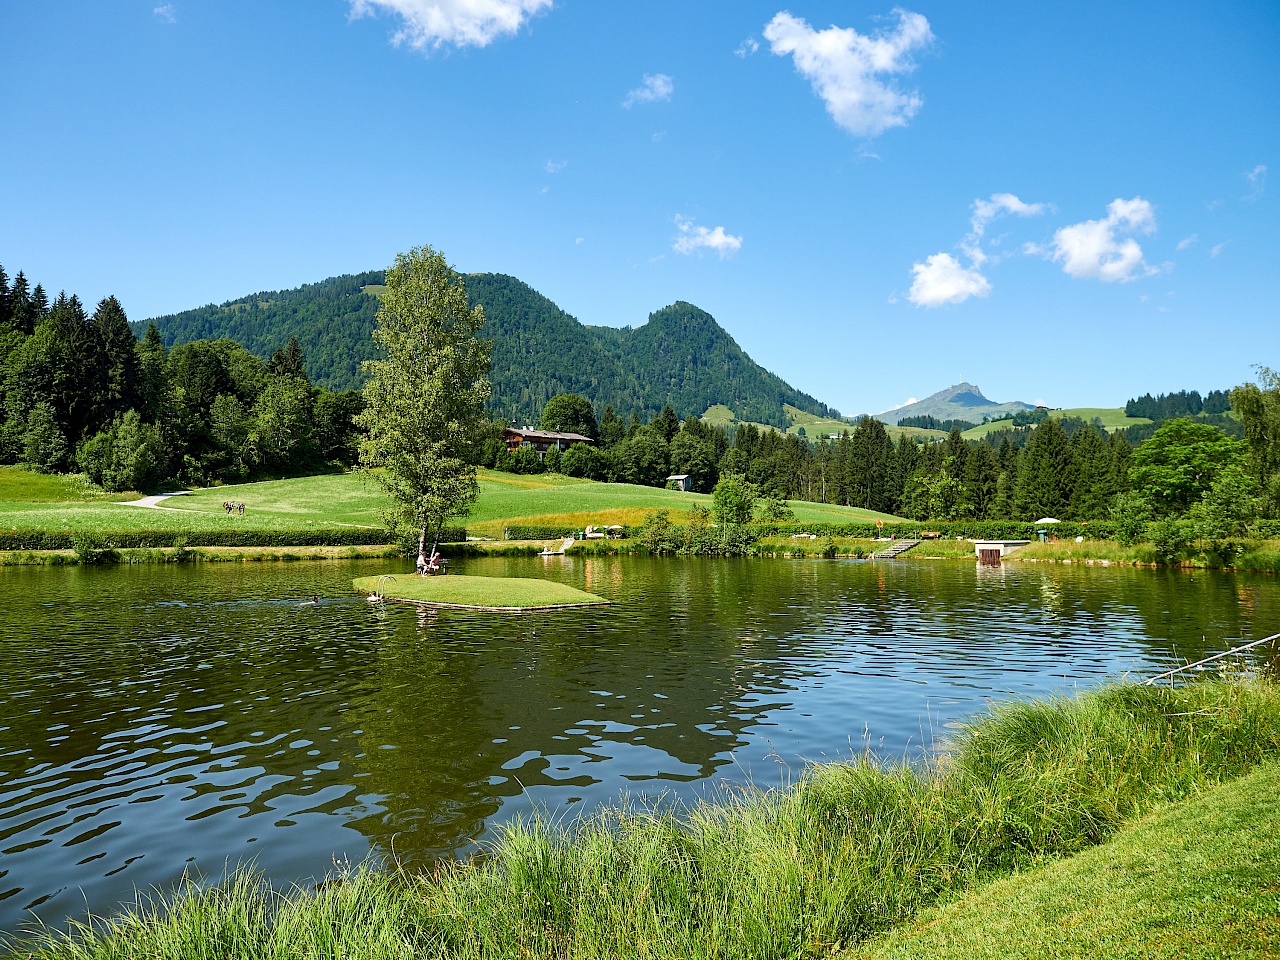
[134,271,832,428]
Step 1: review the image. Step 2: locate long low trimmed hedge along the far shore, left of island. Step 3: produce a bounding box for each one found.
[0,526,467,550]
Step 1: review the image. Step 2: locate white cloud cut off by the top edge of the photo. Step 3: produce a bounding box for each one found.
[348,0,552,50]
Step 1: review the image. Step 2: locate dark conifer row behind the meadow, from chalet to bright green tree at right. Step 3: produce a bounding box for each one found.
[480,396,1132,520]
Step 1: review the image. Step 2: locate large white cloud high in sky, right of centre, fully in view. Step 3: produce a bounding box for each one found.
[764,8,933,137]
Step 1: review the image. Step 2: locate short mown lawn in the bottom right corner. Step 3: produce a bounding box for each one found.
[845,763,1280,960]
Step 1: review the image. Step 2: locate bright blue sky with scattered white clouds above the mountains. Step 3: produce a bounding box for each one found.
[0,0,1280,413]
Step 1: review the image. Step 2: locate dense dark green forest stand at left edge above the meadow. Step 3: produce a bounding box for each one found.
[0,266,362,490]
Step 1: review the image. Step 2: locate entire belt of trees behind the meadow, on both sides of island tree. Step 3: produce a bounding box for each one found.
[0,259,1280,530]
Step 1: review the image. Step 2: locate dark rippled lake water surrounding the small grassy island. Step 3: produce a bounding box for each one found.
[0,557,1280,931]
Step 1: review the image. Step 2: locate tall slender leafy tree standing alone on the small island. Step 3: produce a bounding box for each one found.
[356,247,492,556]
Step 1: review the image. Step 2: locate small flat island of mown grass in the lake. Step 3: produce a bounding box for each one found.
[352,573,608,612]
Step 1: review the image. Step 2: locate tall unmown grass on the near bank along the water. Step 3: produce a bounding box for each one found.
[12,681,1280,960]
